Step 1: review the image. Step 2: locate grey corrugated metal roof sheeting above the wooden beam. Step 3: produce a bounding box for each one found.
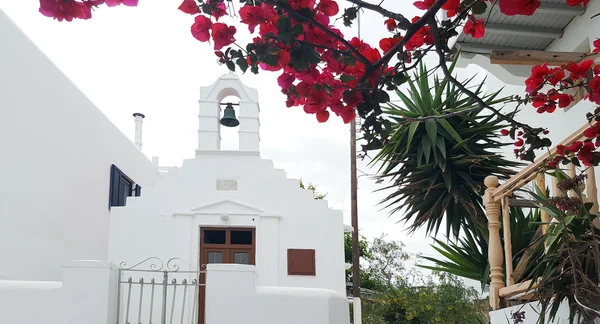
[456,0,585,54]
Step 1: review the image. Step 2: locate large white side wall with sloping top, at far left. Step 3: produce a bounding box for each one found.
[0,10,156,280]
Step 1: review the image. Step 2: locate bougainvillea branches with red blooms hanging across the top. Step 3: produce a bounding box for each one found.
[40,0,600,160]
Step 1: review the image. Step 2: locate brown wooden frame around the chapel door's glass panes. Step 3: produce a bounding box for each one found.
[198,226,256,324]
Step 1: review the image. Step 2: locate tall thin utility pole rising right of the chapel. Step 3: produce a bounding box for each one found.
[350,11,362,324]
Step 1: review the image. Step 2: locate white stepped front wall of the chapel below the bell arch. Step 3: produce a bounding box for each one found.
[109,151,345,293]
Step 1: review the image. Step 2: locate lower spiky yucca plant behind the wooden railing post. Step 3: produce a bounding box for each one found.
[419,207,541,289]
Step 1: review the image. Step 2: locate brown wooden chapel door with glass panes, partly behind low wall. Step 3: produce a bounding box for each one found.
[198,227,256,324]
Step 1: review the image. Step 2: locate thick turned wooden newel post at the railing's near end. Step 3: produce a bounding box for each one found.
[483,176,504,310]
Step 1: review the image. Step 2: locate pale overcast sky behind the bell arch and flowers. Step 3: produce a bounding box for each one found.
[0,0,492,264]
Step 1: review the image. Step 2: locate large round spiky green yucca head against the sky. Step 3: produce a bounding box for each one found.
[371,61,520,237]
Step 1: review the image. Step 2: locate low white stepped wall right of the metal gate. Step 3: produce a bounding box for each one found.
[205,264,350,324]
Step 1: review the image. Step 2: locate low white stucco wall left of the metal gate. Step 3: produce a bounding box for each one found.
[0,261,117,324]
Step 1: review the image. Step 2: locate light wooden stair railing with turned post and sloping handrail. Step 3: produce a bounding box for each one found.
[483,123,600,310]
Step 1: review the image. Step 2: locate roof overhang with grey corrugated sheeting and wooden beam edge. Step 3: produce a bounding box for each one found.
[454,0,585,85]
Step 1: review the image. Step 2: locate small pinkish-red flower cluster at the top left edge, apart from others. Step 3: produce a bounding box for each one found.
[40,0,138,21]
